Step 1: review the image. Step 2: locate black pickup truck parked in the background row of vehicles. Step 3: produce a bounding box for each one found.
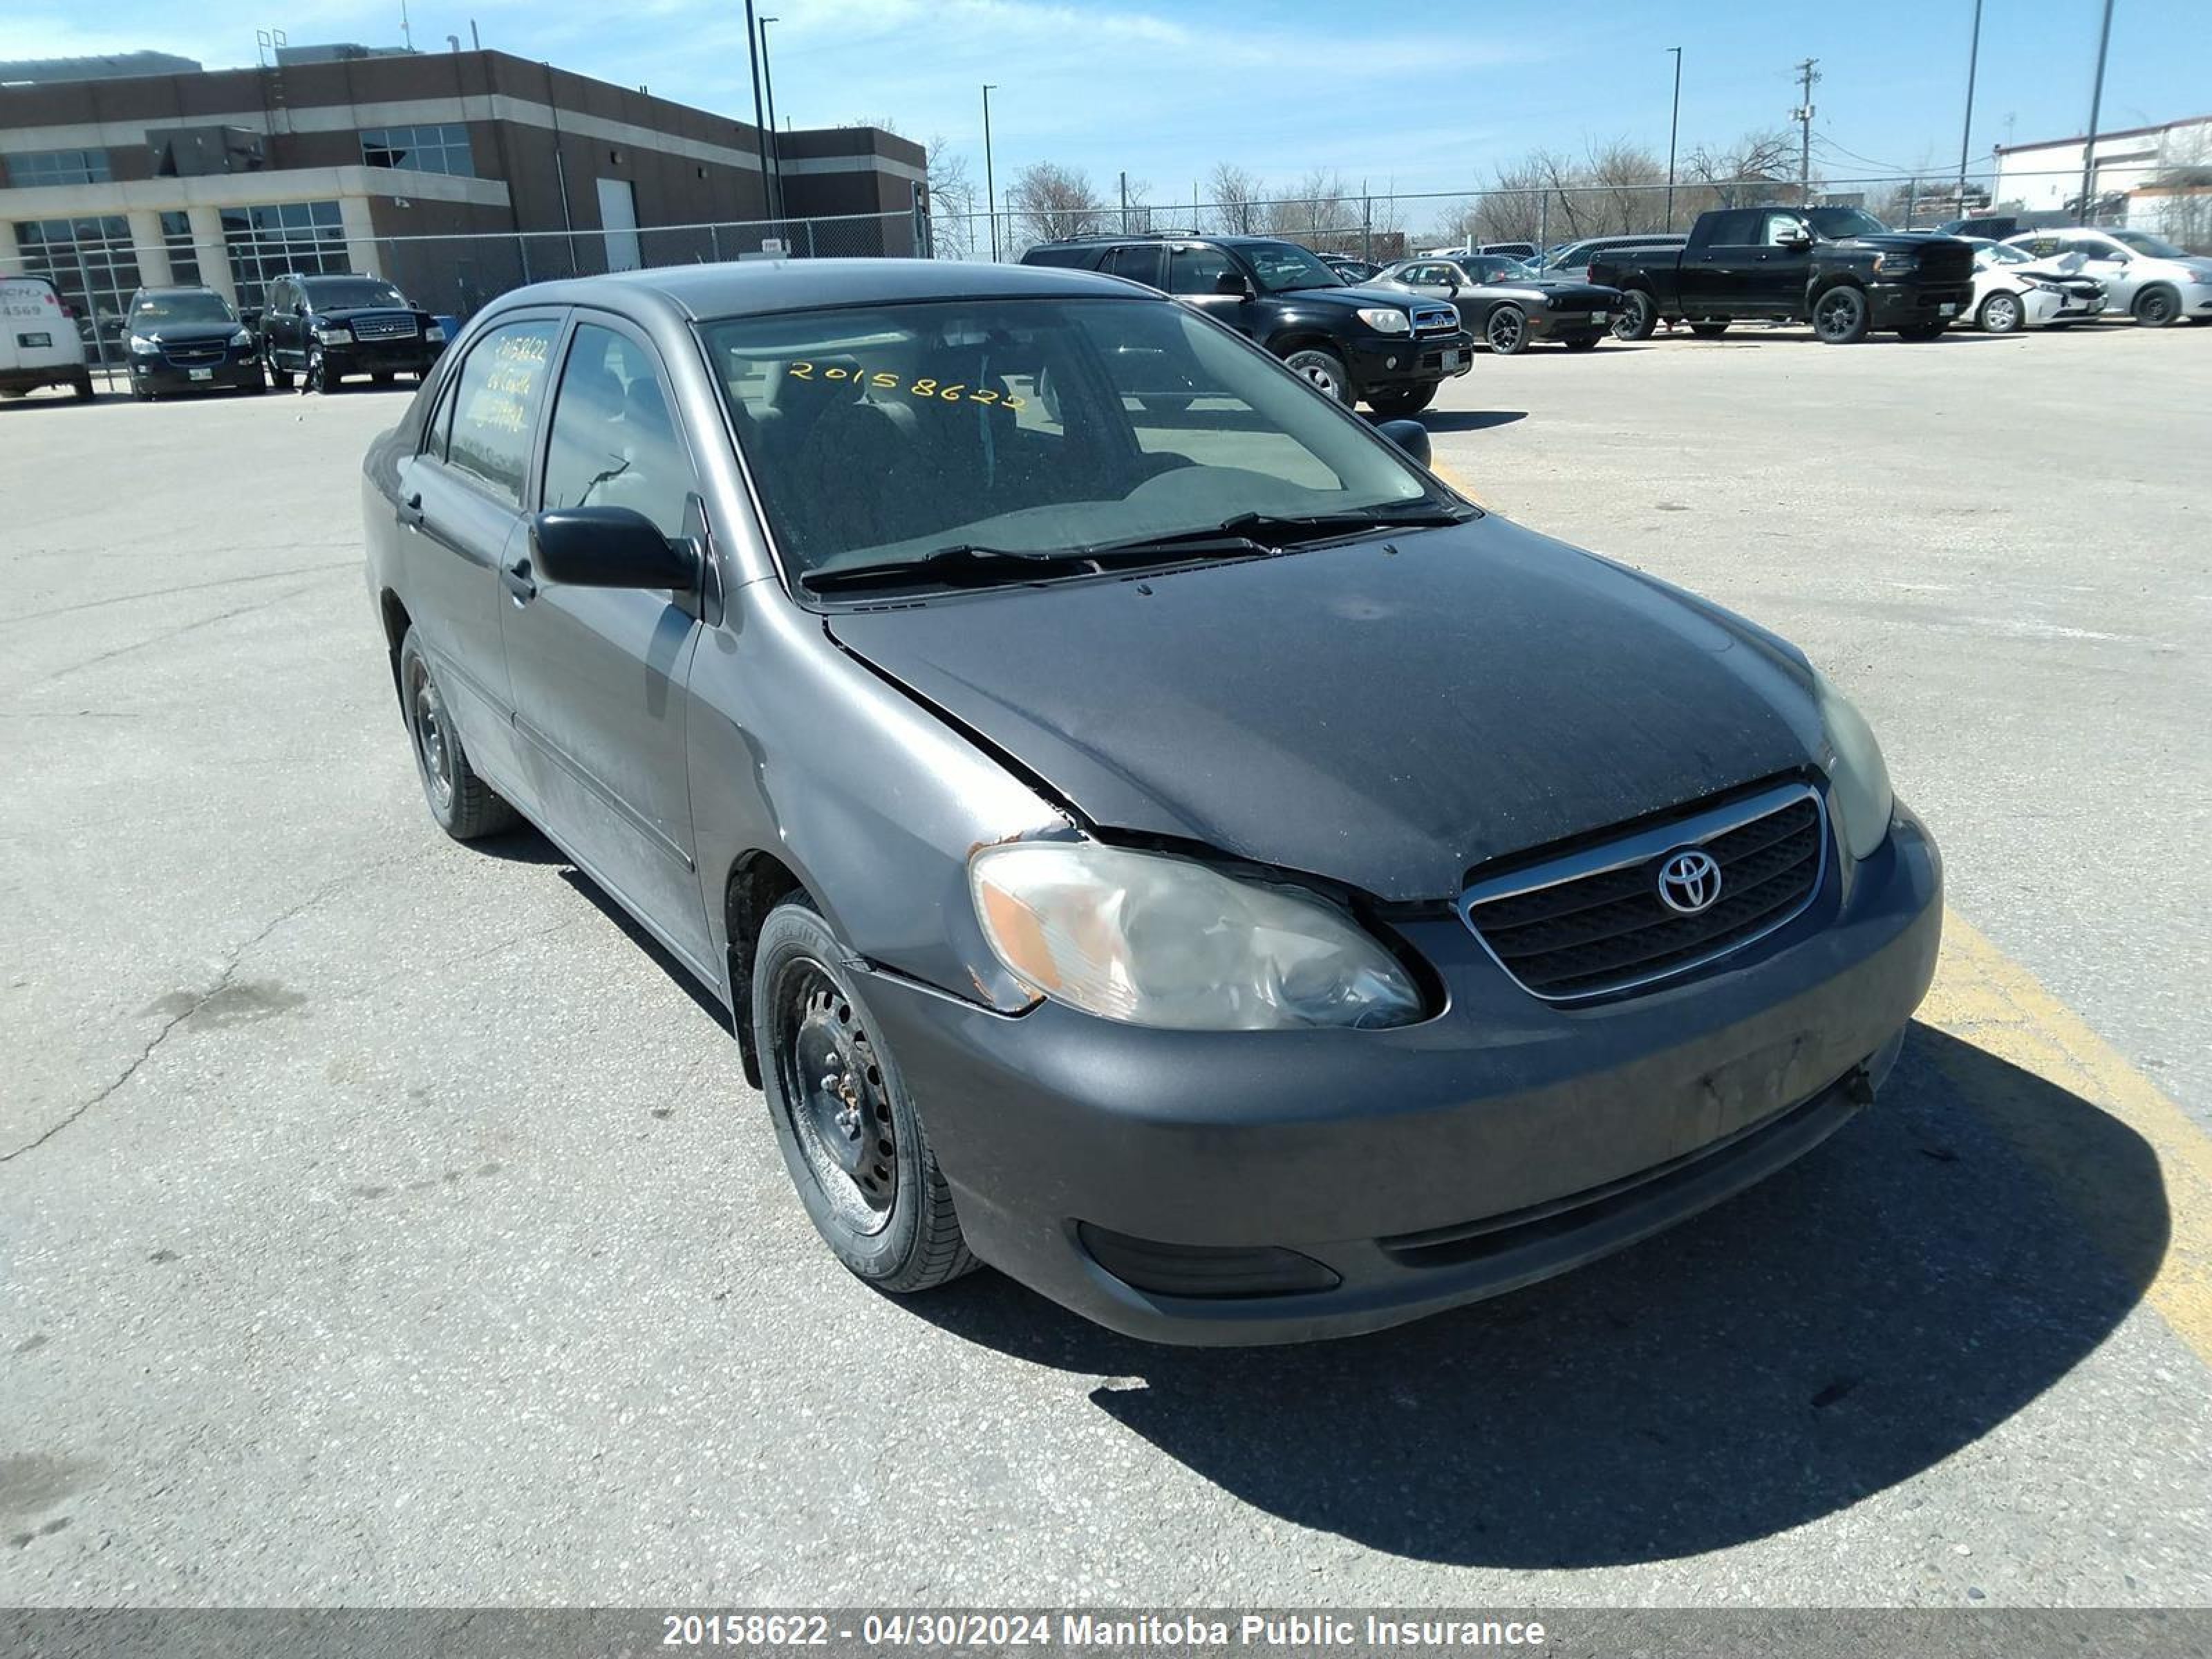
[1591,208,1973,345]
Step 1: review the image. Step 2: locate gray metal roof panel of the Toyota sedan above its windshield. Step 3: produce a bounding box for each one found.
[498,259,1165,321]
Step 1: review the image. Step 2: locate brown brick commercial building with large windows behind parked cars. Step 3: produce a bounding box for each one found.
[0,48,927,336]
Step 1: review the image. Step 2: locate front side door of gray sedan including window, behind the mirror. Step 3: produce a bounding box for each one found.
[498,310,715,980]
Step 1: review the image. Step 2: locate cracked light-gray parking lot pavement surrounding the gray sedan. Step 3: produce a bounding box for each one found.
[0,328,2212,1606]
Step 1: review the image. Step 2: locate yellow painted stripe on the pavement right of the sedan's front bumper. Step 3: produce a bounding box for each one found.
[1920,911,2212,1365]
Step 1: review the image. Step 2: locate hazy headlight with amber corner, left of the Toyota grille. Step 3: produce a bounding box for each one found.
[969,841,1420,1031]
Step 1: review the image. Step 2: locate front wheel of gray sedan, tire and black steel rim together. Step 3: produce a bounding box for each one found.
[750,898,975,1294]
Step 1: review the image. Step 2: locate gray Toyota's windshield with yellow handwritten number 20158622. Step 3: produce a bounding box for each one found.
[704,299,1447,579]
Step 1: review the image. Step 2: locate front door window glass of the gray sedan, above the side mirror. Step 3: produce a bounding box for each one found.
[544,323,697,535]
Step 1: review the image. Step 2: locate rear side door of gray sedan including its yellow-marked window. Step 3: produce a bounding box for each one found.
[396,310,562,809]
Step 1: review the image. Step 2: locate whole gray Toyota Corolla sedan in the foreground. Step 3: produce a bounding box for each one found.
[365,261,1942,1342]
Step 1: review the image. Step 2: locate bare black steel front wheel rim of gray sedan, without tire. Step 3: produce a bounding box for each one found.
[774,958,898,1235]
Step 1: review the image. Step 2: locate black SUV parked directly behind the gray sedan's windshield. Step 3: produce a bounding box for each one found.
[1022,232,1473,418]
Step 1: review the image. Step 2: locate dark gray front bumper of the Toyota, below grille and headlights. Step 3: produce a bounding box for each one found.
[865,807,1942,1342]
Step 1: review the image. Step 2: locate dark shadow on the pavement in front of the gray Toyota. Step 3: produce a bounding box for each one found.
[903,1027,2168,1568]
